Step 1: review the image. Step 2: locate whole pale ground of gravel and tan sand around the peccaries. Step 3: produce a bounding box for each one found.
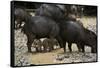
[15,17,97,66]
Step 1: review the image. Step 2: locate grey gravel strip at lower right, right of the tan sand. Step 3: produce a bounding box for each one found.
[56,52,97,63]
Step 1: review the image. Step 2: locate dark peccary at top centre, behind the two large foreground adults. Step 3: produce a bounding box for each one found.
[35,4,65,21]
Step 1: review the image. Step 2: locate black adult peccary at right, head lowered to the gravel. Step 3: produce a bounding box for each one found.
[60,20,97,53]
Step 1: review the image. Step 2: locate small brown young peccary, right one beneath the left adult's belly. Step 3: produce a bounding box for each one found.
[42,38,59,52]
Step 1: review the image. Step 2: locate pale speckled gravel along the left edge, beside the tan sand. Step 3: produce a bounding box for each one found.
[15,29,30,66]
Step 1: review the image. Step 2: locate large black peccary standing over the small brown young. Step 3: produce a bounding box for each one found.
[22,16,59,51]
